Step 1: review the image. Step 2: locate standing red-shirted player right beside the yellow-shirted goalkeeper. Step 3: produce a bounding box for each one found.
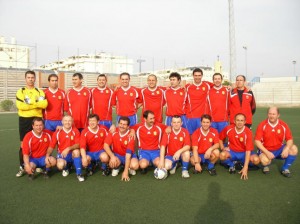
[44,74,66,132]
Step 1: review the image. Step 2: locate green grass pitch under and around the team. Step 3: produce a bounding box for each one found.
[0,108,300,224]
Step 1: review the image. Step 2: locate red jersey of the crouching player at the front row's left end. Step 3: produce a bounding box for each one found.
[22,131,51,158]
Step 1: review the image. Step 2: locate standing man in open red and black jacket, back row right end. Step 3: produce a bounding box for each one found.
[229,75,256,128]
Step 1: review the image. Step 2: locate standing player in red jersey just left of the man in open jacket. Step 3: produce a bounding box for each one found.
[207,73,230,133]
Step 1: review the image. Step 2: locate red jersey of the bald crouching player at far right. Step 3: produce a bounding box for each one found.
[255,119,293,151]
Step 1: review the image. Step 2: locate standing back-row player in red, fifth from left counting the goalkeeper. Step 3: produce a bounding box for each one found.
[112,72,140,126]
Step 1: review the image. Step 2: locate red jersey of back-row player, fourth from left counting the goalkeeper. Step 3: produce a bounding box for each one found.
[91,87,113,121]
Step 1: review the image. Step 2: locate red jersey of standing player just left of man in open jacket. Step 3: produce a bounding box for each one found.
[206,86,229,122]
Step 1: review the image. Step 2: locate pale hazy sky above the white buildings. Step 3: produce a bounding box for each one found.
[0,0,300,78]
